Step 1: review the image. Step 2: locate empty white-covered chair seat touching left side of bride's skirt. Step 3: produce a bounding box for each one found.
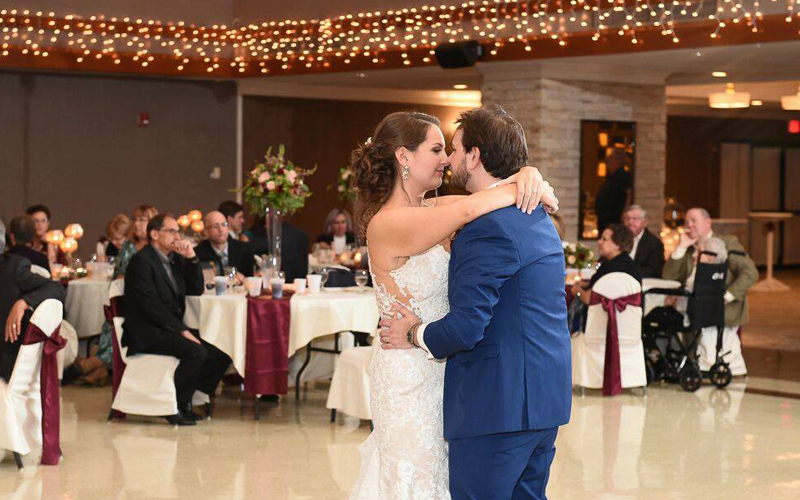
[326,346,373,423]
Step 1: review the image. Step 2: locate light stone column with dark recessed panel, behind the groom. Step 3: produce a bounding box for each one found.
[481,70,667,241]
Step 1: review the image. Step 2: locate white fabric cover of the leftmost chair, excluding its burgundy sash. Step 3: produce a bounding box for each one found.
[0,299,64,468]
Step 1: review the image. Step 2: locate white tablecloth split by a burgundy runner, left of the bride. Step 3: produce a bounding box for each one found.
[183,289,379,376]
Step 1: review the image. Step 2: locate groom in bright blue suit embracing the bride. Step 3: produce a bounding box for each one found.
[381,107,572,500]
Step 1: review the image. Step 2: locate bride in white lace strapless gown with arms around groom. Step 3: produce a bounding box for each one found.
[350,112,558,500]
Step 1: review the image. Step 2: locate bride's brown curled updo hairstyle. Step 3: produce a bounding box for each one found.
[350,111,441,236]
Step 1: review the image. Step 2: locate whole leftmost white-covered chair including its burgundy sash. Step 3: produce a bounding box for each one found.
[0,299,66,469]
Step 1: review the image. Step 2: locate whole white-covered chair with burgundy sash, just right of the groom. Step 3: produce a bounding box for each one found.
[572,273,647,396]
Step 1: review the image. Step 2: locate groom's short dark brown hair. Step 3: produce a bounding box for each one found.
[456,106,528,179]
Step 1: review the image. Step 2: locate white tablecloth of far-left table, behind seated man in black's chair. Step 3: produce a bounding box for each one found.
[64,278,110,339]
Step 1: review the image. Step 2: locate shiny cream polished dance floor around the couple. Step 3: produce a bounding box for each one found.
[0,377,800,500]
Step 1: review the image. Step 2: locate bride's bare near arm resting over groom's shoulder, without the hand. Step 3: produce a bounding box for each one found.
[367,184,517,258]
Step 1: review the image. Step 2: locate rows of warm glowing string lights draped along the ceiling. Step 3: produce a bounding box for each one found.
[0,0,800,74]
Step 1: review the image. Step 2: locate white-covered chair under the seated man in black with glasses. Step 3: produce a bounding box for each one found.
[108,279,209,420]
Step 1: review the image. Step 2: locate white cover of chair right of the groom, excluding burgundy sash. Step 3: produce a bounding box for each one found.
[572,272,647,391]
